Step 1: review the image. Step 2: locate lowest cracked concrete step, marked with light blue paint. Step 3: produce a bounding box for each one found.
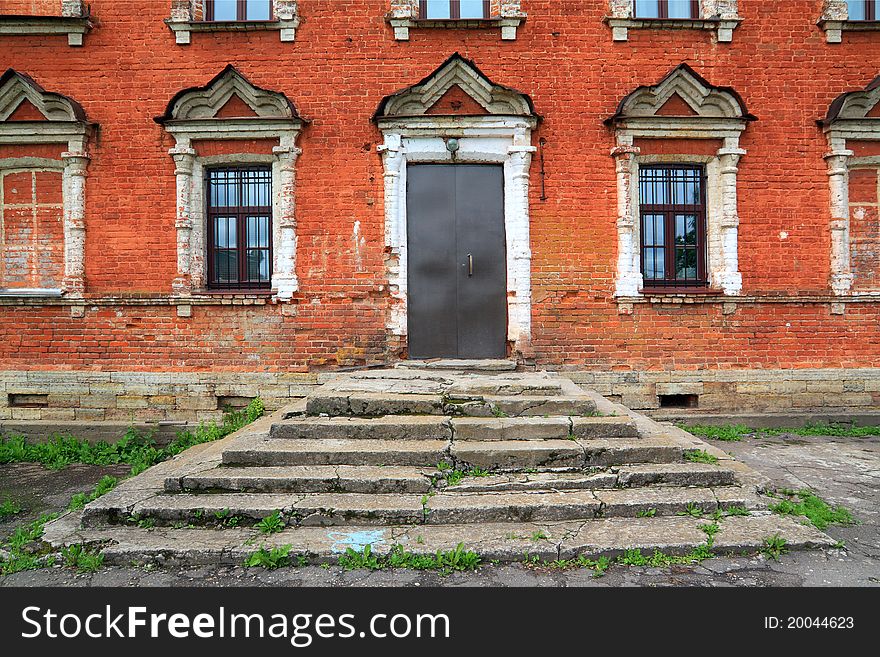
[43,514,834,566]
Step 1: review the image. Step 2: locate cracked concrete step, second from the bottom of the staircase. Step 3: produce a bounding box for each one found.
[84,488,757,526]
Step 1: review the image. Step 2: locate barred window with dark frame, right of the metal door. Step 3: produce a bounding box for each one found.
[639,165,707,287]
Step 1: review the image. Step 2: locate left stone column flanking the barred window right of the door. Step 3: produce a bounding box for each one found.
[611,143,643,297]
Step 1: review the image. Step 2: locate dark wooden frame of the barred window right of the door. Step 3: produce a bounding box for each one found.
[639,162,709,291]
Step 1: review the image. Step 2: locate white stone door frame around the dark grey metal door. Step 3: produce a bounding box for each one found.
[378,115,537,353]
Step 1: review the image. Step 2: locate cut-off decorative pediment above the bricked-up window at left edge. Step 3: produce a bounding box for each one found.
[0,69,86,123]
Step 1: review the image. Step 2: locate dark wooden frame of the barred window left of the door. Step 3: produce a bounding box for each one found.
[205,165,273,291]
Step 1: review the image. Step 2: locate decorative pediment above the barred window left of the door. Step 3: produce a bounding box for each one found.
[155,64,300,123]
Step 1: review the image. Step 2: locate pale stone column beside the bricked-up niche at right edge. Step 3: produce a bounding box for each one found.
[825,149,853,295]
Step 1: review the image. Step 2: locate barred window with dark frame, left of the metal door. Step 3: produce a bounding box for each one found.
[207,167,272,290]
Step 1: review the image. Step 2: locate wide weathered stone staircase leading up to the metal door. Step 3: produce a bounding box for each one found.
[46,363,832,563]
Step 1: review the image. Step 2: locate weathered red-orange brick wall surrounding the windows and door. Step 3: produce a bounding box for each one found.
[0,0,880,370]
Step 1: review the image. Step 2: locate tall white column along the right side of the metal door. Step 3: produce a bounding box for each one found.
[504,128,537,356]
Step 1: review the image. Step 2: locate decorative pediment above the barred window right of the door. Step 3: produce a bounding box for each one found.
[607,64,755,124]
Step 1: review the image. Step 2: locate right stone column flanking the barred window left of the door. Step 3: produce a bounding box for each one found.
[272,138,302,301]
